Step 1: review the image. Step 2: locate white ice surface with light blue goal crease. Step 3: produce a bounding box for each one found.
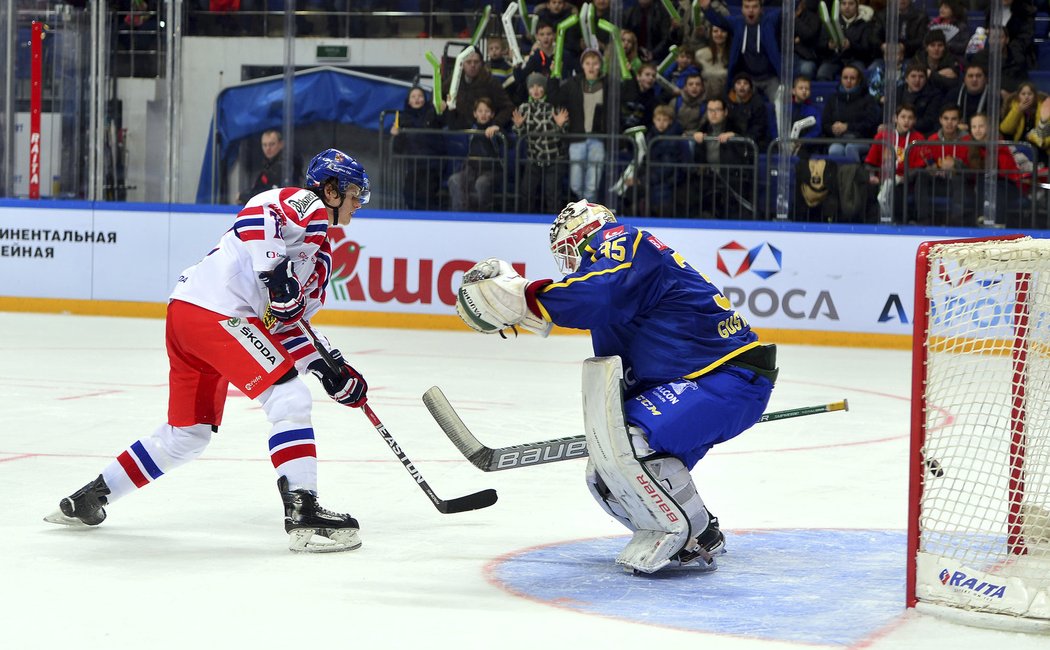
[0,314,1048,650]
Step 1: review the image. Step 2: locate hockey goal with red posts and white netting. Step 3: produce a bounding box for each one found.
[906,235,1050,632]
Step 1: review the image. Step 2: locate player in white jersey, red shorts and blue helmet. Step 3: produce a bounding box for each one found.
[44,149,369,551]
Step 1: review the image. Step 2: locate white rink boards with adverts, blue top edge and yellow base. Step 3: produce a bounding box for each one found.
[0,201,1046,348]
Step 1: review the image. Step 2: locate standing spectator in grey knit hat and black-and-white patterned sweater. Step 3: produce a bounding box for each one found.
[511,72,569,213]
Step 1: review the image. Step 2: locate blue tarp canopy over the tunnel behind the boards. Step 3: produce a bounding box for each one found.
[196,67,411,203]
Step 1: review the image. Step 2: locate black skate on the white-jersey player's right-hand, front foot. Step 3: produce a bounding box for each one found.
[277,477,361,552]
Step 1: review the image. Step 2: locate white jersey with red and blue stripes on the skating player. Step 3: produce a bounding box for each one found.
[170,187,332,372]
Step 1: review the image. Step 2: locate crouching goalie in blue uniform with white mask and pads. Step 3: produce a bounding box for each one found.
[457,201,778,573]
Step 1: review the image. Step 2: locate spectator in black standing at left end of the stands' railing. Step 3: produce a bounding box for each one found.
[391,86,445,210]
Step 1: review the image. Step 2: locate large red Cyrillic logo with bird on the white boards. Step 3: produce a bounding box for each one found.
[329,228,525,307]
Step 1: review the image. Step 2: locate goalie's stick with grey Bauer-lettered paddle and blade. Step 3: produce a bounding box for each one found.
[423,386,849,471]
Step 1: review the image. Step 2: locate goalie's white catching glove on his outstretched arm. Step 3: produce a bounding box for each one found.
[456,257,552,337]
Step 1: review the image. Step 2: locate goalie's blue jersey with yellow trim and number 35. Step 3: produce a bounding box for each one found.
[536,223,758,397]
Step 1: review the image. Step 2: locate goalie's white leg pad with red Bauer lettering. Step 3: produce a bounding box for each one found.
[583,357,708,573]
